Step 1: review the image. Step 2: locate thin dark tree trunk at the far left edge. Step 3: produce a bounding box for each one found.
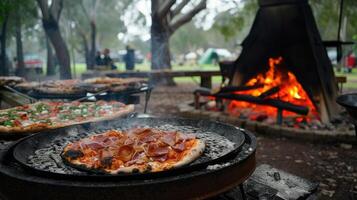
[0,15,9,76]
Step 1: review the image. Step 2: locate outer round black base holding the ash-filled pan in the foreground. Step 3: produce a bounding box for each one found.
[0,130,256,200]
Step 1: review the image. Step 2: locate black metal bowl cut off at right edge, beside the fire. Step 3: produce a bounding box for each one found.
[336,93,357,137]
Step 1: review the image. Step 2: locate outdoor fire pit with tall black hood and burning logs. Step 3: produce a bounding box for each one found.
[191,0,354,141]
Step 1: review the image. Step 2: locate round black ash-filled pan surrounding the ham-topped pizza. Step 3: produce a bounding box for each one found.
[13,118,245,180]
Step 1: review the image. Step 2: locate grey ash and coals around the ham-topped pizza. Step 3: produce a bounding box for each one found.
[27,124,236,175]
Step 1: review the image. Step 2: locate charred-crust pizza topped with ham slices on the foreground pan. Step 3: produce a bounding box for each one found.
[61,128,205,174]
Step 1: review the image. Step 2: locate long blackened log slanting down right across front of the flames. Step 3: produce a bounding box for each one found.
[216,94,309,115]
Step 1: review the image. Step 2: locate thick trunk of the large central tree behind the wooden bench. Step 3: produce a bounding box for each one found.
[151,16,175,85]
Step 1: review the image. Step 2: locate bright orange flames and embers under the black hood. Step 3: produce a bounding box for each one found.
[228,57,318,122]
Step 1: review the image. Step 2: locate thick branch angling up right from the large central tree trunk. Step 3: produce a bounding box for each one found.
[170,0,207,33]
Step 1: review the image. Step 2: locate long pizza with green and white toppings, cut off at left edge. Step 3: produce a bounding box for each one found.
[0,101,134,133]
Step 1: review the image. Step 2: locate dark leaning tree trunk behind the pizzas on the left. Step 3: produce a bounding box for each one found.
[42,16,72,79]
